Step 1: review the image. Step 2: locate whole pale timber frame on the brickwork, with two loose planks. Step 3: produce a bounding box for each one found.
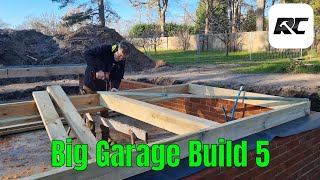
[0,84,310,179]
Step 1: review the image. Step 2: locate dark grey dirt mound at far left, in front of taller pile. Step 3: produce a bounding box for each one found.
[0,29,59,66]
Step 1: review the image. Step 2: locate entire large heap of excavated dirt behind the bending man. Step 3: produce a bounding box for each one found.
[0,26,155,71]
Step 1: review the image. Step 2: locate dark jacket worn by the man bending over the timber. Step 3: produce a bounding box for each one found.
[84,44,125,91]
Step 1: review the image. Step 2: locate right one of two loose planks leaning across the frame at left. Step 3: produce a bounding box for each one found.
[47,86,97,158]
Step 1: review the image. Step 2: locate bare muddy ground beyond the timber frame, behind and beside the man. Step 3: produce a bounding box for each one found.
[0,64,320,108]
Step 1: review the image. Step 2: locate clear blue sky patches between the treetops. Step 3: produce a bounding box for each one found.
[0,0,199,27]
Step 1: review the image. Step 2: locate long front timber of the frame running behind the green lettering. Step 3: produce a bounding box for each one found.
[29,102,312,179]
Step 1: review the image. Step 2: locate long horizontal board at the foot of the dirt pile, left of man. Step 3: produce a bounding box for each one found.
[6,65,86,78]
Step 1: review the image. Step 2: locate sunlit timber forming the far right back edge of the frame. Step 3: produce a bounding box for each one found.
[189,84,293,109]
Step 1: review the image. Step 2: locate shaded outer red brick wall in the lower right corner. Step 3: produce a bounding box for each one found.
[185,128,320,180]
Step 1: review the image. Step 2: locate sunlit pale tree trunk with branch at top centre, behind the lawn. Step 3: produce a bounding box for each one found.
[129,0,168,35]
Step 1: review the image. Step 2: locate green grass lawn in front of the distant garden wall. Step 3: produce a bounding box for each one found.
[150,50,320,73]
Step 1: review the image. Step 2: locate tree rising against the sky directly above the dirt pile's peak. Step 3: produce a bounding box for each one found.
[52,0,119,26]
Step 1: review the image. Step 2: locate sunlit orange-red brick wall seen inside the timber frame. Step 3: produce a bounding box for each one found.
[120,80,272,123]
